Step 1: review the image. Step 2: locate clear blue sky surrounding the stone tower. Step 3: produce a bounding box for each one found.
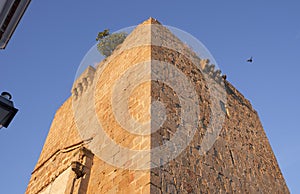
[0,0,300,194]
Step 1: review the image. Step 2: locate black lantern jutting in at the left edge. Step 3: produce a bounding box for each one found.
[0,92,18,128]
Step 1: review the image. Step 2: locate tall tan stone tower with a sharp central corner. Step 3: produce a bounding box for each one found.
[26,18,289,194]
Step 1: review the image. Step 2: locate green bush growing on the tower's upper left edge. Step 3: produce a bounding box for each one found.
[96,29,127,57]
